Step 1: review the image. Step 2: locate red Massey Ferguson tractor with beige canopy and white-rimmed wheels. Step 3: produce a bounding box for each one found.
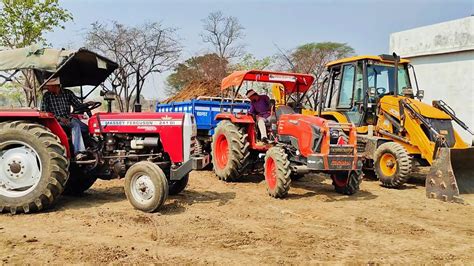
[0,47,208,214]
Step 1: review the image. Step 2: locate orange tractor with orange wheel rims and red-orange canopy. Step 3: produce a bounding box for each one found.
[212,70,362,198]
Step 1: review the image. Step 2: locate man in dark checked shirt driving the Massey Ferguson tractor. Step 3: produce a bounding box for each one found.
[41,78,89,161]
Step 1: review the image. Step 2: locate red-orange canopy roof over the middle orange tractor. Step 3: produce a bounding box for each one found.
[221,70,314,94]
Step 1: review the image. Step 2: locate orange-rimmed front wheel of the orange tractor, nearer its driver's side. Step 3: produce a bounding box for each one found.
[265,147,291,198]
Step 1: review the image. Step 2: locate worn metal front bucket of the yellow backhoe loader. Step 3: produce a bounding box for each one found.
[426,147,474,203]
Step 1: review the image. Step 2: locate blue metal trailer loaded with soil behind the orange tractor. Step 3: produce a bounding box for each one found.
[156,97,250,151]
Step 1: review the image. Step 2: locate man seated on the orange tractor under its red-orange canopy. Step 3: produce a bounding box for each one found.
[246,89,272,143]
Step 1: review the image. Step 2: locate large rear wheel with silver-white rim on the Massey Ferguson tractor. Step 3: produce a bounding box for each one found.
[0,121,69,214]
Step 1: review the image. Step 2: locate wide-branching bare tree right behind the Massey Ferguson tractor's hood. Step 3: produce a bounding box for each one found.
[86,21,182,112]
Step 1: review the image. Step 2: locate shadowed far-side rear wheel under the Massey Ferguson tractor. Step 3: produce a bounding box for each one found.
[63,164,97,196]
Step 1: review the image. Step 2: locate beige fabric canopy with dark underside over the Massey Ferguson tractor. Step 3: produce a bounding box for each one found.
[0,46,118,87]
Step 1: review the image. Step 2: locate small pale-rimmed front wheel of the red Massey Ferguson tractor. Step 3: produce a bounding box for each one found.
[125,161,169,212]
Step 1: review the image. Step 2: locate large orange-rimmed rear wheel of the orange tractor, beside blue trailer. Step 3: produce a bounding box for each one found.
[211,120,250,181]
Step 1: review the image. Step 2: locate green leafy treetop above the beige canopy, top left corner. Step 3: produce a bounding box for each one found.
[0,0,72,48]
